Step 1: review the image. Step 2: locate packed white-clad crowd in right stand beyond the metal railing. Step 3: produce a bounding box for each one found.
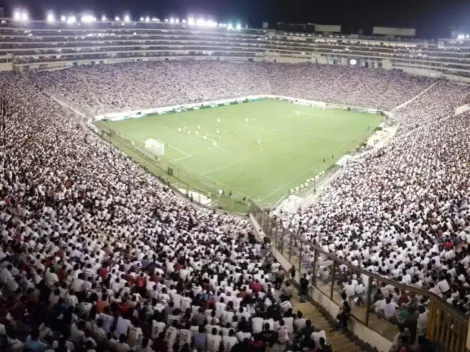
[277,77,470,323]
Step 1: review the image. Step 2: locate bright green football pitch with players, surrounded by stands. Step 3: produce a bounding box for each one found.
[97,100,381,209]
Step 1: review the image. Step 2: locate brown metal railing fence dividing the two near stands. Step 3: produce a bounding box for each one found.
[250,202,468,352]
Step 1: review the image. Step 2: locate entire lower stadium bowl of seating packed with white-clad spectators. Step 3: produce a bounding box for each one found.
[0,61,470,352]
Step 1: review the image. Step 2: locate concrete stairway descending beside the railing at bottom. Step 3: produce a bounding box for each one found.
[291,289,377,352]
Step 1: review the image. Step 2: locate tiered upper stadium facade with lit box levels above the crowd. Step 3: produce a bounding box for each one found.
[0,18,470,82]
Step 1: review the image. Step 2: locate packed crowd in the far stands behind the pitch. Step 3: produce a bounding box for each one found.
[31,60,433,114]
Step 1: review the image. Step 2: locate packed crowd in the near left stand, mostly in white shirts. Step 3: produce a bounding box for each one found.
[0,73,338,352]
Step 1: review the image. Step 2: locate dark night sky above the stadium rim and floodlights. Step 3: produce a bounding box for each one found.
[0,0,470,37]
